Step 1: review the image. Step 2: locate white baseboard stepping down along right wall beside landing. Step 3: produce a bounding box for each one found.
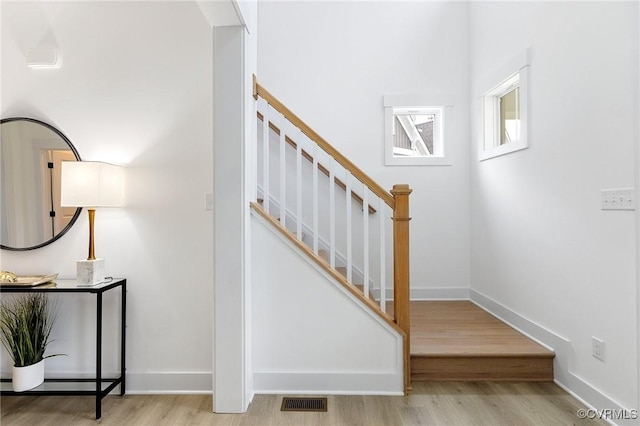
[470,289,638,426]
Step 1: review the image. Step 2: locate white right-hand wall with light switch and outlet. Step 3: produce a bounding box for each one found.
[470,2,638,409]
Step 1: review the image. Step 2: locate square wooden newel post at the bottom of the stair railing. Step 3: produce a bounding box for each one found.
[391,184,411,393]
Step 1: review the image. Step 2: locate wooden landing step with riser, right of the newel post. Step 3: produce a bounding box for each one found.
[402,301,555,381]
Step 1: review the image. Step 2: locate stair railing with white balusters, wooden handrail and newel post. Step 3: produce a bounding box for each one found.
[251,76,411,393]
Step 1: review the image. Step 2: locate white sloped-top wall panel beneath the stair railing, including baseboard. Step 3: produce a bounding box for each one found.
[251,212,404,395]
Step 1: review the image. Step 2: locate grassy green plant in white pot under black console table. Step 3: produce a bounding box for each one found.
[0,293,61,392]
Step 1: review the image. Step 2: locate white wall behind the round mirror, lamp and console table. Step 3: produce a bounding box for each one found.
[1,2,213,392]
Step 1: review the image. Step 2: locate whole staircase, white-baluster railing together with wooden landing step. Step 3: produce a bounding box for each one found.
[251,78,554,393]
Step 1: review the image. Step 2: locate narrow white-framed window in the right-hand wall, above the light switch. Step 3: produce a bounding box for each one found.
[480,52,529,160]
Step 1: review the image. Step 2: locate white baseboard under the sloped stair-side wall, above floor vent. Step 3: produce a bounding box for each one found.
[253,372,404,395]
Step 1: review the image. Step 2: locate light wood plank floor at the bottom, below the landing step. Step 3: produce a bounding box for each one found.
[0,382,606,426]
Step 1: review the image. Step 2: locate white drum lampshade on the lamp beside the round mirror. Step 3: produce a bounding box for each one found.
[60,161,124,207]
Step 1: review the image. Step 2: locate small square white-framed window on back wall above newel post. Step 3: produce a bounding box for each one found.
[384,95,451,165]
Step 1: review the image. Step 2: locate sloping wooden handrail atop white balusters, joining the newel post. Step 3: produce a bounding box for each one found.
[253,77,395,209]
